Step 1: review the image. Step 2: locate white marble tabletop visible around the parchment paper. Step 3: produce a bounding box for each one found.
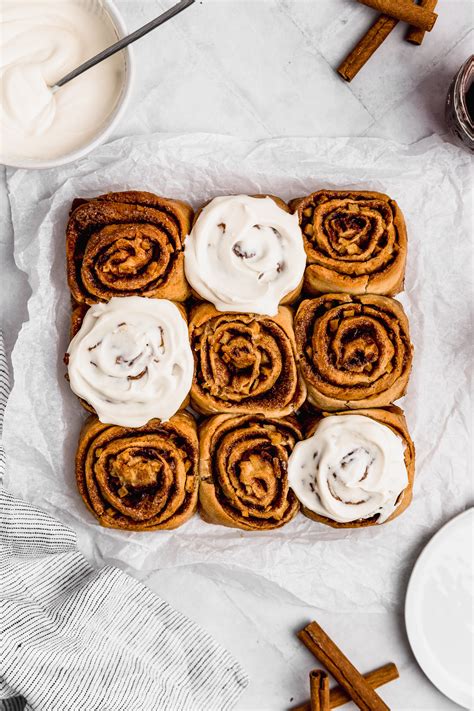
[0,0,473,711]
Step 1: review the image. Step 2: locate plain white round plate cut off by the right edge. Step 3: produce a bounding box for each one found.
[405,508,474,709]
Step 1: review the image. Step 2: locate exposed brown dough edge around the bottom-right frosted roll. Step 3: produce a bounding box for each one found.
[301,405,415,528]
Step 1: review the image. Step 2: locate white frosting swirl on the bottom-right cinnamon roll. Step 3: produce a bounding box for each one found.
[288,415,408,523]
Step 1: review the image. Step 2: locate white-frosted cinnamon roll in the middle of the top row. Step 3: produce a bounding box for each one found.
[185,195,306,316]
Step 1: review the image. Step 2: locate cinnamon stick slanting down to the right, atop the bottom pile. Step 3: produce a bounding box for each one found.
[298,622,389,711]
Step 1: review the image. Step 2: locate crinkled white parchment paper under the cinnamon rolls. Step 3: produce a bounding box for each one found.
[4,134,472,611]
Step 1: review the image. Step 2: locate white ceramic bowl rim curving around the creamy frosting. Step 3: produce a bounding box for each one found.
[0,0,135,169]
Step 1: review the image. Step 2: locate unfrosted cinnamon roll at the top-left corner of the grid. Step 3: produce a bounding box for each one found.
[66,191,193,304]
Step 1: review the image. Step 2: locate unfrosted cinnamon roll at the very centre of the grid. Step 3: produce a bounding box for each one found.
[189,303,306,417]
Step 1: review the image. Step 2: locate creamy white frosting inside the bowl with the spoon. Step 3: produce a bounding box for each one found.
[0,0,125,160]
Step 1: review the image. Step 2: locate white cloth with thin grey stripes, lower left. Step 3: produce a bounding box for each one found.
[0,333,248,711]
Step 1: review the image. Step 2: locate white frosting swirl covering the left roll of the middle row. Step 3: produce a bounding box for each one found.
[66,296,193,427]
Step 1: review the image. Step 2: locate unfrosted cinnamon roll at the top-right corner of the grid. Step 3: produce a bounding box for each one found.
[290,190,407,296]
